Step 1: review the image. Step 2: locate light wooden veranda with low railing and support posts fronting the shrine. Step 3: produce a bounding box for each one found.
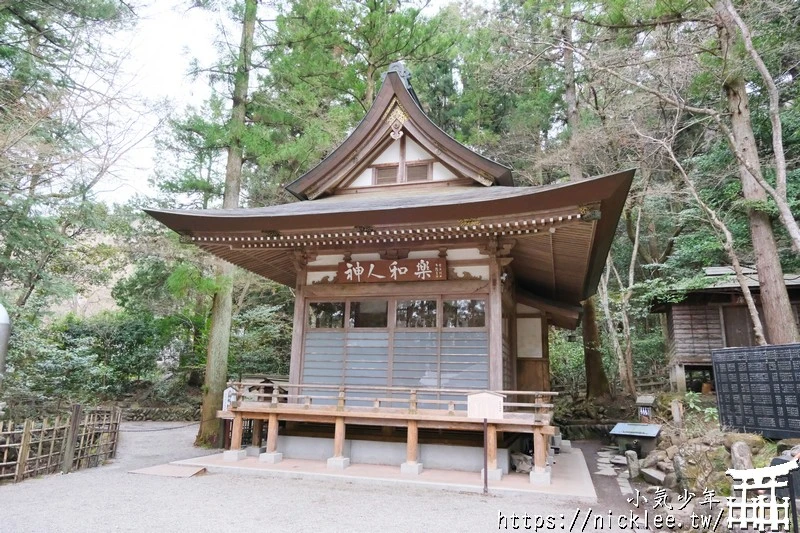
[218,383,558,478]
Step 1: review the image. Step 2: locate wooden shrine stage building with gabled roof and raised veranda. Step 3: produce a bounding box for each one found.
[148,65,634,482]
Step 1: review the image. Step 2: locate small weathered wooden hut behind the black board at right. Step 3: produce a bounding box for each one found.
[653,267,800,392]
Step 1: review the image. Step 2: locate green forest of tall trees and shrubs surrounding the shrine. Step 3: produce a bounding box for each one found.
[0,0,800,432]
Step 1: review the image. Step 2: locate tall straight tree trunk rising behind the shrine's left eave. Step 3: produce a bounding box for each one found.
[195,0,257,447]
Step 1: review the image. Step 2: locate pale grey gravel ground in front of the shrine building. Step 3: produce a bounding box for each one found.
[0,422,636,533]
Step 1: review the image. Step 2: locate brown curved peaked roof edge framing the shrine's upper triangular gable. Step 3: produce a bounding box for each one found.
[286,66,513,200]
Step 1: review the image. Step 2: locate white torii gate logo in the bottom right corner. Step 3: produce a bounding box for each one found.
[725,459,800,531]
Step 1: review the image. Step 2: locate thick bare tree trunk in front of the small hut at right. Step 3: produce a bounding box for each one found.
[715,3,798,344]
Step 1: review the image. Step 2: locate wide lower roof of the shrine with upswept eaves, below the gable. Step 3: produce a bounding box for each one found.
[142,170,635,327]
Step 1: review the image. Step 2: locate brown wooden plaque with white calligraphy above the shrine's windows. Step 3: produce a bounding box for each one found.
[336,258,447,283]
